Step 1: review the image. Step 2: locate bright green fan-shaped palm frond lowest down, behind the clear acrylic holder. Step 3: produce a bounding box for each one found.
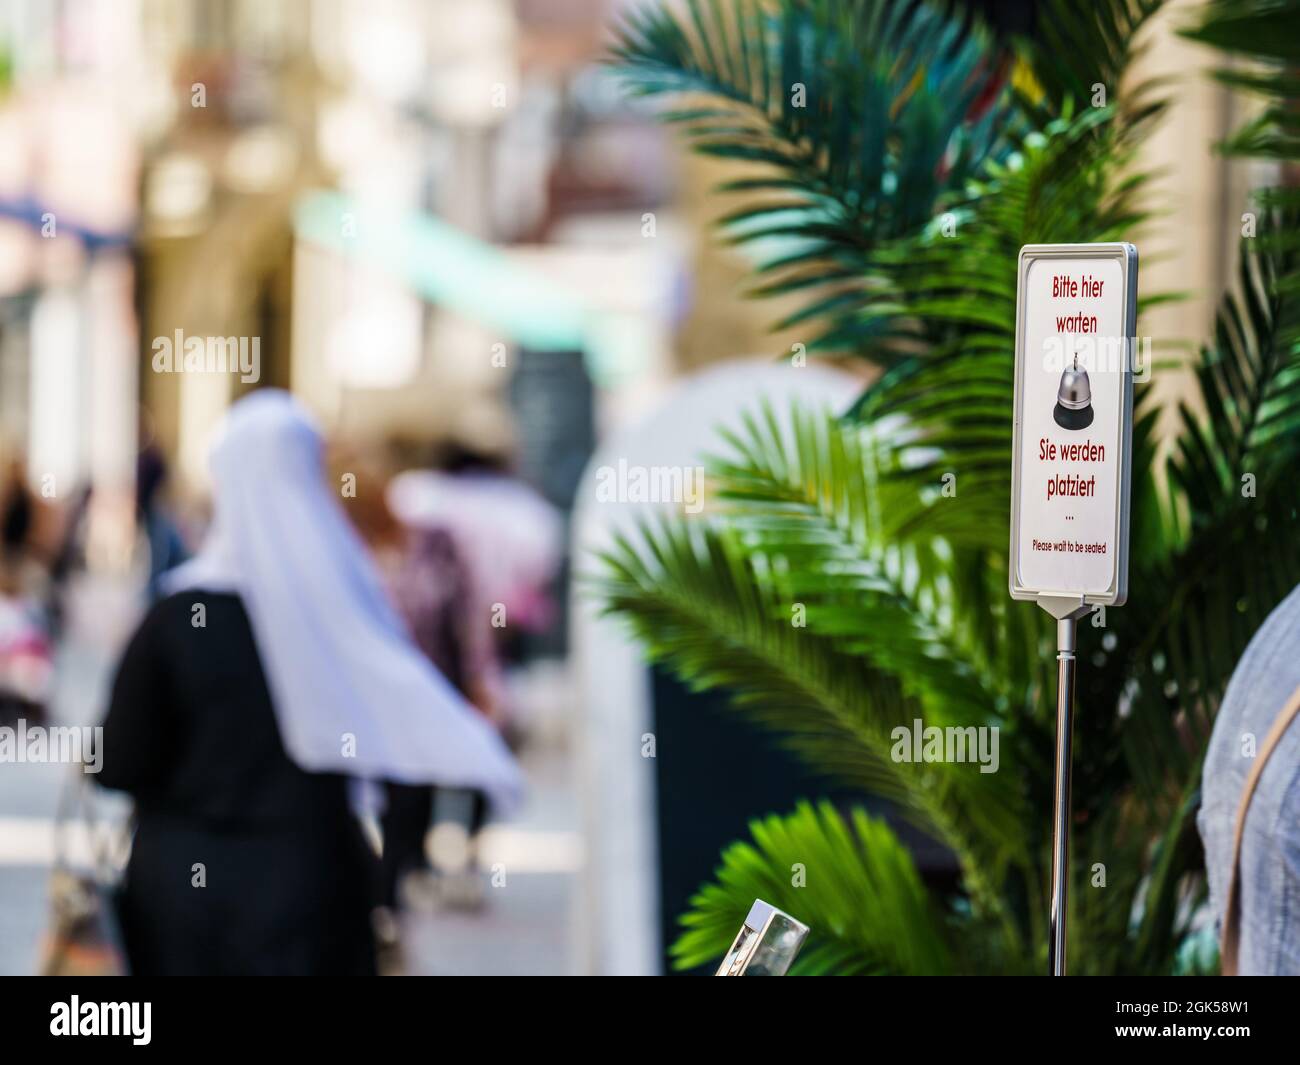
[672,802,950,975]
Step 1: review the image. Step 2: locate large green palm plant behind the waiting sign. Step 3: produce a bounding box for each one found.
[594,0,1300,974]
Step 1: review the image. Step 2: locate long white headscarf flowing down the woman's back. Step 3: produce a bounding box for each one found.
[165,389,523,810]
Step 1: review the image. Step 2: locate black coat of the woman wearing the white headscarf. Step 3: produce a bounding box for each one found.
[99,592,376,974]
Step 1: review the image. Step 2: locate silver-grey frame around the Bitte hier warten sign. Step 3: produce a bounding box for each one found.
[1008,242,1138,616]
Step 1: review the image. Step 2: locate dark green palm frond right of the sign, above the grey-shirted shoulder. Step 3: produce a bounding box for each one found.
[1076,211,1300,941]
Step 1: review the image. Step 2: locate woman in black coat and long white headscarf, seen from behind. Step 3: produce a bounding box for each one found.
[100,390,521,974]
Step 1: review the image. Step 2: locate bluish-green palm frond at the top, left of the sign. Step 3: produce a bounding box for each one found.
[612,0,1014,350]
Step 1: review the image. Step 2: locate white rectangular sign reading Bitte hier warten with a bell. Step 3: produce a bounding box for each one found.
[1010,243,1138,606]
